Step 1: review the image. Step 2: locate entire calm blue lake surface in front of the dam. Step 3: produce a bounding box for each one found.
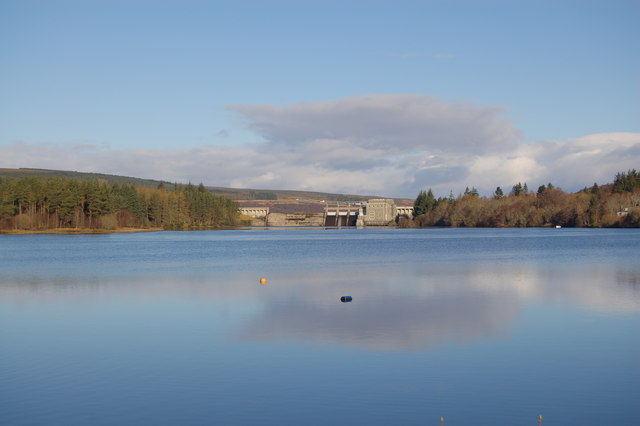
[0,229,640,426]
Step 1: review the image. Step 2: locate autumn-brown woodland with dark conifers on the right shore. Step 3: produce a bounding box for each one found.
[410,169,640,227]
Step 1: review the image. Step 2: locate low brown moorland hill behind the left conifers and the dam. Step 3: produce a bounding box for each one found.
[0,168,406,202]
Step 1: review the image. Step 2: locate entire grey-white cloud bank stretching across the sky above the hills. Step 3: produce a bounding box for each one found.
[0,94,640,197]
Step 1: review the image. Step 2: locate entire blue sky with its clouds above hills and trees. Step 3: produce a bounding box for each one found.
[0,0,640,198]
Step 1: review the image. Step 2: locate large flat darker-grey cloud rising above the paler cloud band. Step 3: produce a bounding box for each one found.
[229,95,519,155]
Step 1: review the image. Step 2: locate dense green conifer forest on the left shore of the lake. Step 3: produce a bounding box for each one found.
[0,176,238,231]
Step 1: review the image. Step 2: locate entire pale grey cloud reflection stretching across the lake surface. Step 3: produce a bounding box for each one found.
[0,263,640,351]
